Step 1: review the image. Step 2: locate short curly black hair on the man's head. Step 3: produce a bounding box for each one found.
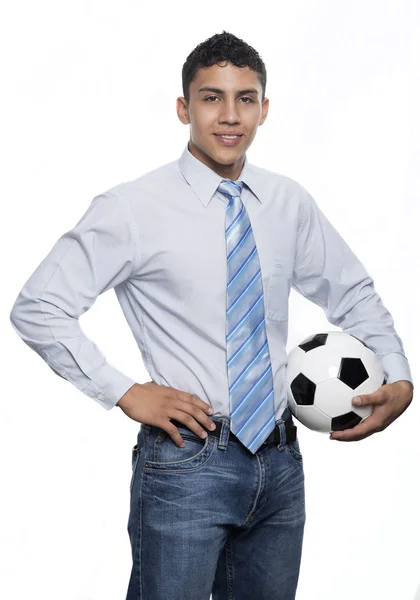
[182,30,267,102]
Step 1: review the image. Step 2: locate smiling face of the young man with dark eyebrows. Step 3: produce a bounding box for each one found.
[176,62,269,180]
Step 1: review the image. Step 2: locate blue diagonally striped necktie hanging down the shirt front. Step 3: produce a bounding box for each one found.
[217,179,276,454]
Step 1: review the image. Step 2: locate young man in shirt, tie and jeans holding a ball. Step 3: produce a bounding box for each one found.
[11,32,413,600]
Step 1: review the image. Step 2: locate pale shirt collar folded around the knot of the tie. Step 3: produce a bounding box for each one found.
[178,143,263,207]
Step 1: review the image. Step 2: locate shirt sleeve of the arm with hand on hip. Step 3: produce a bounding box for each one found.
[10,192,140,410]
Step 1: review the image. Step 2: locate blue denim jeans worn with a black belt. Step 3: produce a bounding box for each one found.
[126,408,306,600]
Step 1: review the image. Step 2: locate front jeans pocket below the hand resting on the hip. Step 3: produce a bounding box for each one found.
[144,428,215,471]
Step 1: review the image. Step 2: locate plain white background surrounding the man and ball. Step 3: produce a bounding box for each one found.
[0,0,420,600]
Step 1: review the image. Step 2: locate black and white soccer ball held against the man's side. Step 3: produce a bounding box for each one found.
[286,331,386,433]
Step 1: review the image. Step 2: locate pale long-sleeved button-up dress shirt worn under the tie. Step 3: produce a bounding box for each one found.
[10,143,413,419]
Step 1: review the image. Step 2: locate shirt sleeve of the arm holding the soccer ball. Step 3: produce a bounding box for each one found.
[292,187,414,387]
